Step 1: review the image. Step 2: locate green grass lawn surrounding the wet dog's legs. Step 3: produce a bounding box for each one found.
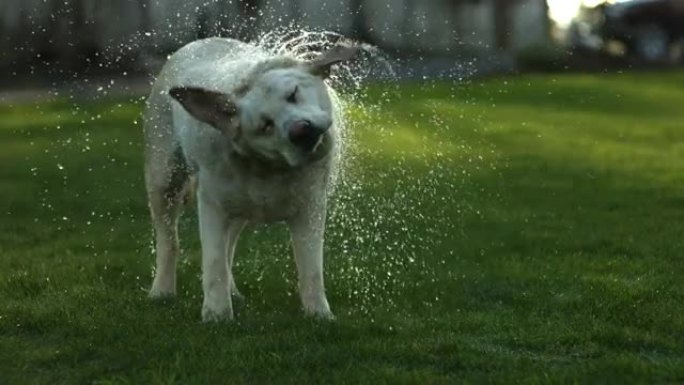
[0,72,684,384]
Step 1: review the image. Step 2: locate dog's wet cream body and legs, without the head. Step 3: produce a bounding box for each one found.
[144,38,358,321]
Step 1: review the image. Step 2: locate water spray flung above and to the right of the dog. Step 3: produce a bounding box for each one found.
[238,29,488,314]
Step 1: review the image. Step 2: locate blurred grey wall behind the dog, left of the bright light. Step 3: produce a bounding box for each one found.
[0,0,549,78]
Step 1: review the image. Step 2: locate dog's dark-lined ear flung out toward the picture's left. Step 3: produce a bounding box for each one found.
[169,87,237,131]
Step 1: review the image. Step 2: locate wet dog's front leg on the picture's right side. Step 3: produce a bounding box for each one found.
[289,204,334,319]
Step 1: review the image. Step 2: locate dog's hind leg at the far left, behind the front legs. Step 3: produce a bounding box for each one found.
[145,144,190,298]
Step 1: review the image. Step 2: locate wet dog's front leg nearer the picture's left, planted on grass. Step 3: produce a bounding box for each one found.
[198,194,233,322]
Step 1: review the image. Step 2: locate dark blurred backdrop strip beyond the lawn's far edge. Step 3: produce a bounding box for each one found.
[0,0,684,90]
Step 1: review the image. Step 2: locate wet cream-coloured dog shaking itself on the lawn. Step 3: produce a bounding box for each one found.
[143,38,359,321]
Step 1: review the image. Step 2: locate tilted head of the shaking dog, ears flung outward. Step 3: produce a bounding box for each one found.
[169,45,358,167]
